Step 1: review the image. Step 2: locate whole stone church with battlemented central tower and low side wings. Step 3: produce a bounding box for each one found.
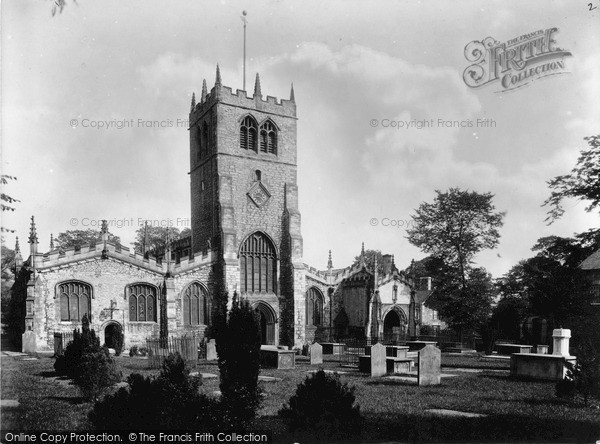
[13,66,442,351]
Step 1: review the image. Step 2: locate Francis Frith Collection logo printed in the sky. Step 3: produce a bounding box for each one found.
[463,28,571,92]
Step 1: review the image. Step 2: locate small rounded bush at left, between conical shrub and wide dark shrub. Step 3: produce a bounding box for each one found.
[75,347,121,401]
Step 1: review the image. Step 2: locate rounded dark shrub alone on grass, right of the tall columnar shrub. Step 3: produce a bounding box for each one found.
[279,370,363,438]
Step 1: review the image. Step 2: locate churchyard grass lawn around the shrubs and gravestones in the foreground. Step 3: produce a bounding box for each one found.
[2,354,600,442]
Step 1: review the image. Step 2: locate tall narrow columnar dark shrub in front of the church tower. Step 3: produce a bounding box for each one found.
[217,294,262,428]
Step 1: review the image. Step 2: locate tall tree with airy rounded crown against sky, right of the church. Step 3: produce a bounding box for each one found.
[407,188,505,287]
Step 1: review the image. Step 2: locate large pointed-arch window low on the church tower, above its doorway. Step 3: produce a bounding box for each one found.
[240,232,277,293]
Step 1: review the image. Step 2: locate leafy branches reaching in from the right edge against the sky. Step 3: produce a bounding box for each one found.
[543,134,600,224]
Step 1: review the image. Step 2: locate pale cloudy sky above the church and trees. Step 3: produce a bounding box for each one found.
[1,0,600,277]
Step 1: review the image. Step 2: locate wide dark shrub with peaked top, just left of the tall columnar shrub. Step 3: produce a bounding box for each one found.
[89,353,220,430]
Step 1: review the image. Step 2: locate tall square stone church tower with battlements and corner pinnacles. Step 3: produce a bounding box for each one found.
[189,66,305,346]
